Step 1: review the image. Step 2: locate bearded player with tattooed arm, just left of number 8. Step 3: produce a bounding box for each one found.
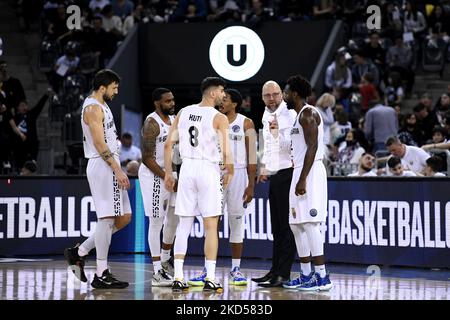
[139,88,178,287]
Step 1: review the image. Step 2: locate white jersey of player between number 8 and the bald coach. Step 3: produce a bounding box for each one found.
[228,113,247,169]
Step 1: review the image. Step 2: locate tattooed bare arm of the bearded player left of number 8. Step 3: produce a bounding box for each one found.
[142,118,164,179]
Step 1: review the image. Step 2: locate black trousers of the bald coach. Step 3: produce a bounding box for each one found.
[269,168,296,279]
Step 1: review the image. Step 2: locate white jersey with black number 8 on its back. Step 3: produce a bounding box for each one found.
[178,104,222,163]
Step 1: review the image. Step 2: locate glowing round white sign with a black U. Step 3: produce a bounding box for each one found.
[209,26,264,81]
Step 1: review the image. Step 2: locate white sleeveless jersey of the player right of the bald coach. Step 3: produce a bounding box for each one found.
[291,104,325,168]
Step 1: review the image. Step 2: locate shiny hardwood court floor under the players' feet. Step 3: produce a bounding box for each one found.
[0,255,450,300]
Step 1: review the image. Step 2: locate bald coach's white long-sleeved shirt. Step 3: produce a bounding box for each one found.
[261,101,297,173]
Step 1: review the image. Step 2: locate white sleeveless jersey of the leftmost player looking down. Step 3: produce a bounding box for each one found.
[81,97,119,159]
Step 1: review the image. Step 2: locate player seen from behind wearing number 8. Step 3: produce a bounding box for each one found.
[164,77,234,292]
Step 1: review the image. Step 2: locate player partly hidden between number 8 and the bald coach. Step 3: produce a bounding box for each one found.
[188,89,256,286]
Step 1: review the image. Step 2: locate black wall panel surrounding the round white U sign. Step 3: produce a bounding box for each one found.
[139,21,335,127]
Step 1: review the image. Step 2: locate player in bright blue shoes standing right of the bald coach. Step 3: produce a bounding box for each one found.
[283,75,332,290]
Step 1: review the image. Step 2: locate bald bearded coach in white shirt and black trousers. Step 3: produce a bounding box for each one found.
[252,81,296,287]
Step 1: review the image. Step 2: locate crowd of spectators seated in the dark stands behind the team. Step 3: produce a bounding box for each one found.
[0,0,450,175]
